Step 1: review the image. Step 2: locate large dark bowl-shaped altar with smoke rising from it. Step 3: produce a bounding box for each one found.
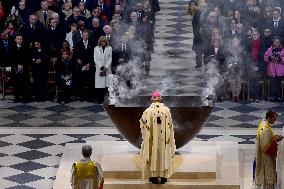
[104,96,213,148]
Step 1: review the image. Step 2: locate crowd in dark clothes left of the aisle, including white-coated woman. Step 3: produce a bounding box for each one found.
[0,0,160,103]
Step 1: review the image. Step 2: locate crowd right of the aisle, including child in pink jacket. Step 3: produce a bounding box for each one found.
[188,0,284,102]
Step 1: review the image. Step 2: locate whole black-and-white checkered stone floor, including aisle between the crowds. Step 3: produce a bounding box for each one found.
[0,0,284,189]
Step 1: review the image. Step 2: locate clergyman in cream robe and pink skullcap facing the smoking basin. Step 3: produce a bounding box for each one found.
[140,92,176,184]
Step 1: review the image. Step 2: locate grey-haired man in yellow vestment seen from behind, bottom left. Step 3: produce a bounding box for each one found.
[71,145,104,189]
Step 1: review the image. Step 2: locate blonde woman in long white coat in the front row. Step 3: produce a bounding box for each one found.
[94,36,112,103]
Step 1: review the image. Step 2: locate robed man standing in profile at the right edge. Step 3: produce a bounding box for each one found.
[254,111,283,189]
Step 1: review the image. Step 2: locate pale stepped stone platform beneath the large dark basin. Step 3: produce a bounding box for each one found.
[53,141,239,189]
